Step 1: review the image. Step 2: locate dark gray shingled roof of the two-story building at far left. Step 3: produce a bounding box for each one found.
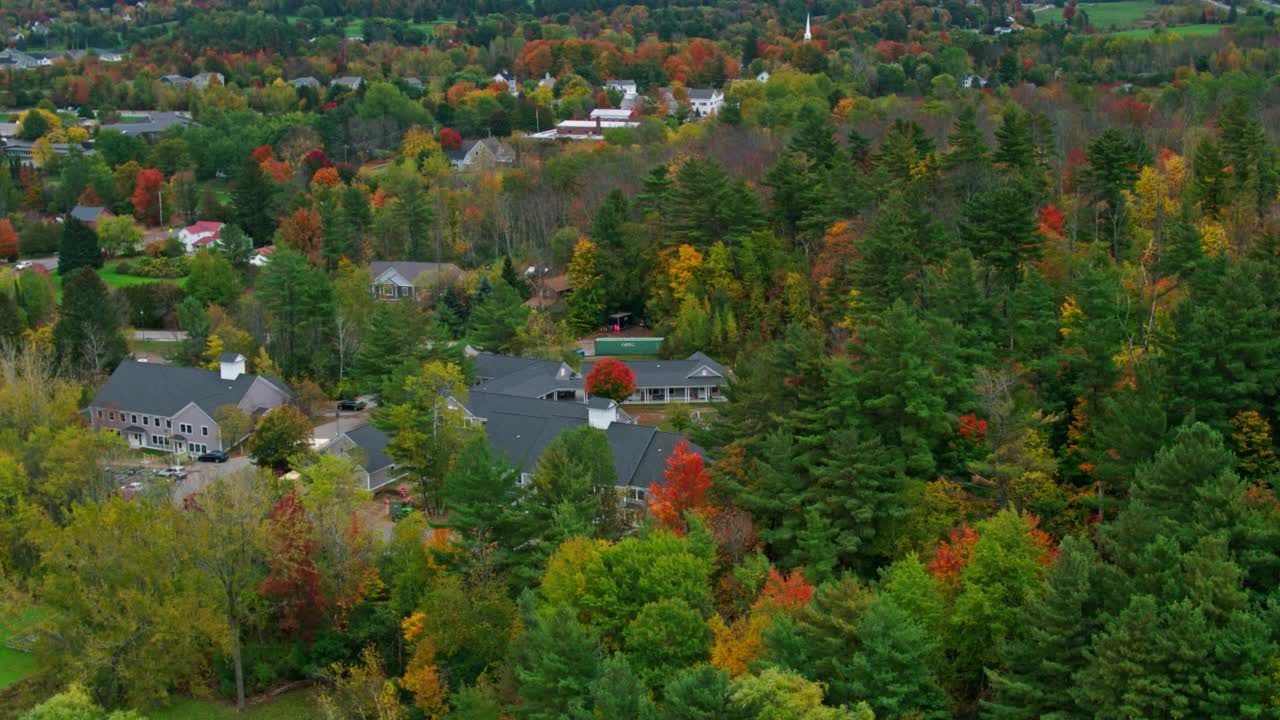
[91,360,293,418]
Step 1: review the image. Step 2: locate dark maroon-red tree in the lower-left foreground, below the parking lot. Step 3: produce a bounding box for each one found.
[257,492,328,637]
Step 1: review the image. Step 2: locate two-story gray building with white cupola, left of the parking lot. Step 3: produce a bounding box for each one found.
[88,352,294,454]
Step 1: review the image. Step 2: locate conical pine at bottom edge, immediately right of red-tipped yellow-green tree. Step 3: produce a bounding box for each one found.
[982,537,1102,720]
